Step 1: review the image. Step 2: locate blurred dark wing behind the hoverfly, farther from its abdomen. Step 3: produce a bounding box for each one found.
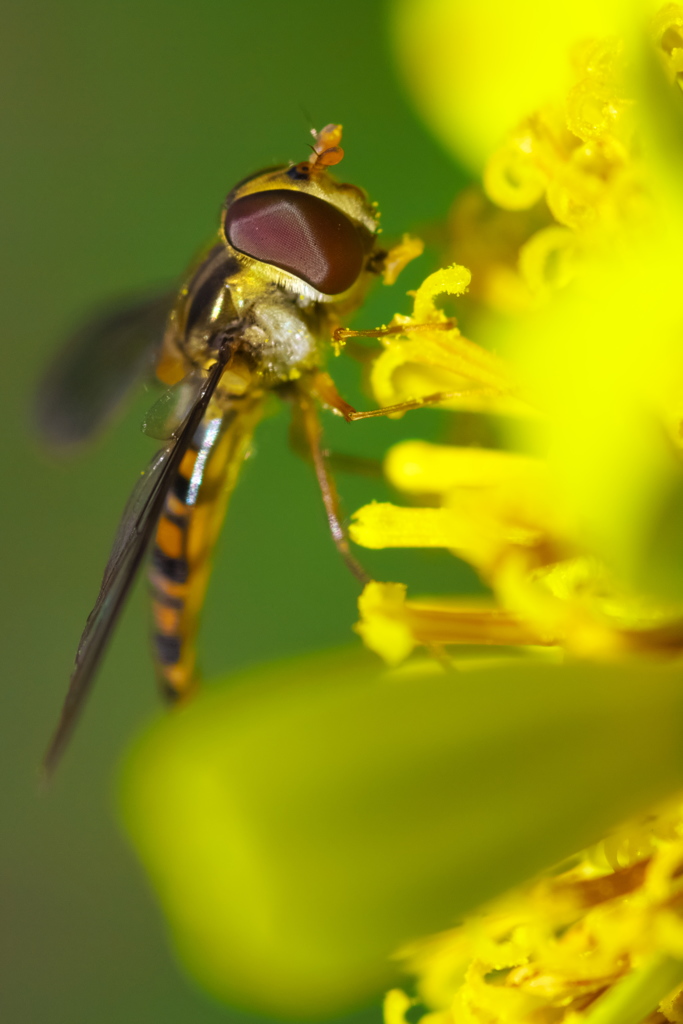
[35,291,175,447]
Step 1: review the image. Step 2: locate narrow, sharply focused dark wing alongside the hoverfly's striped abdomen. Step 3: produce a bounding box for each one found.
[43,345,228,777]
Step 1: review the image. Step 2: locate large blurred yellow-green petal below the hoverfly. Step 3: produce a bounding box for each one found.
[123,652,683,1020]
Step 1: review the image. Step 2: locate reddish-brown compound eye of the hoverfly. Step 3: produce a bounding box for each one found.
[224,188,366,295]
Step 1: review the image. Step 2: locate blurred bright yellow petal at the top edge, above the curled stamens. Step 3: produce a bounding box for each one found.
[394,0,649,169]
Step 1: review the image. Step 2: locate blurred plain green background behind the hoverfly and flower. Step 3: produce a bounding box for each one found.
[0,0,470,1024]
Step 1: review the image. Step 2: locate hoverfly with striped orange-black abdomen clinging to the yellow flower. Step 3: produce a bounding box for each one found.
[40,125,411,773]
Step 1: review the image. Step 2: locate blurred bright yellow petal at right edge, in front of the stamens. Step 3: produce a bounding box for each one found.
[506,239,683,596]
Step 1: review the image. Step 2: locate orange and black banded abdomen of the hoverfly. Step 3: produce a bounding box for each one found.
[150,402,260,700]
